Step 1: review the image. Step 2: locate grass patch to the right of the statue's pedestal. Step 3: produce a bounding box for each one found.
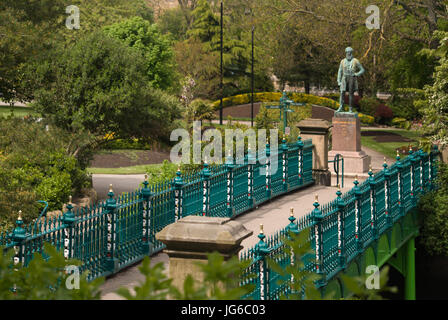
[361,128,420,159]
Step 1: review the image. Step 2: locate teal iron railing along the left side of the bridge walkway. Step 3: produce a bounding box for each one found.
[0,138,314,280]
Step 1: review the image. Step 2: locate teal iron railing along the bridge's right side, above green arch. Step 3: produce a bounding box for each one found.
[240,148,438,300]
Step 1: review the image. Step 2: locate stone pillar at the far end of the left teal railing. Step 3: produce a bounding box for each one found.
[297,119,331,186]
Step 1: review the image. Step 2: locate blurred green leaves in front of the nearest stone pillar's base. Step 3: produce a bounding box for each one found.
[117,252,253,300]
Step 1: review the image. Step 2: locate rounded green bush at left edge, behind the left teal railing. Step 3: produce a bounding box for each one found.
[0,118,90,230]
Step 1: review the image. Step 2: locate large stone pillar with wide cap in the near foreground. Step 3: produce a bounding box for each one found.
[156,216,253,290]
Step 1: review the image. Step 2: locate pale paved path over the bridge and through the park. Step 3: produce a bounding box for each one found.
[93,147,386,300]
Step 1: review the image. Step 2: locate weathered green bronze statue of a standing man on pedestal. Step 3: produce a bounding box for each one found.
[336,47,365,112]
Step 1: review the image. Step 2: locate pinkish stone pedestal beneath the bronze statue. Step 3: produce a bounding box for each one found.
[328,112,371,176]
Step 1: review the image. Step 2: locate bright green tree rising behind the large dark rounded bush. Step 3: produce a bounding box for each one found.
[104,17,176,90]
